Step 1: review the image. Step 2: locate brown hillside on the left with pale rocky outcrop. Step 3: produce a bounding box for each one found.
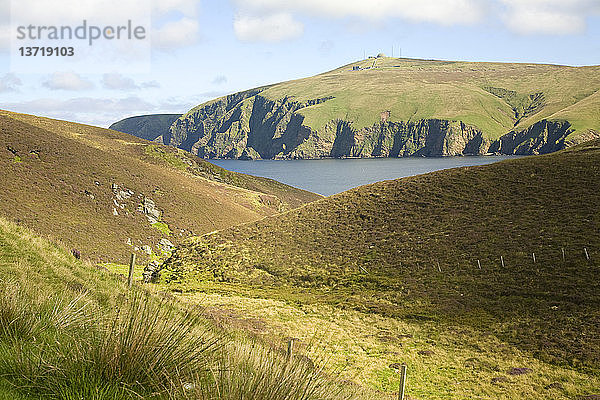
[0,111,319,262]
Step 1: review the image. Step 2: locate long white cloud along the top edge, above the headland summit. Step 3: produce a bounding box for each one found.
[236,0,487,25]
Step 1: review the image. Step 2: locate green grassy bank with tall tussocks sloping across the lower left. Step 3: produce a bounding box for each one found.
[0,217,373,400]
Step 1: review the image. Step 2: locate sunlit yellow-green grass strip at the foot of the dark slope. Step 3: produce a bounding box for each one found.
[182,290,600,400]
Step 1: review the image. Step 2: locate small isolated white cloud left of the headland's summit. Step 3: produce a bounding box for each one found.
[233,12,304,43]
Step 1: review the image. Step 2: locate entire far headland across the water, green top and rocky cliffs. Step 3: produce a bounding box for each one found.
[170,57,600,158]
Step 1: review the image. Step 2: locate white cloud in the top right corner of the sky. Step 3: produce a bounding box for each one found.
[500,0,600,35]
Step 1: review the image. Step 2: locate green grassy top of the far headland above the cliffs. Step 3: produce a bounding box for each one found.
[262,57,600,140]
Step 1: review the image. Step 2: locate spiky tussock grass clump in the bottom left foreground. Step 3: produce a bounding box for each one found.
[0,283,217,399]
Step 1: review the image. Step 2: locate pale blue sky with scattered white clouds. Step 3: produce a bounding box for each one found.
[0,0,600,127]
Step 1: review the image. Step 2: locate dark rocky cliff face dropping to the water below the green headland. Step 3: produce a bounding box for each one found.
[169,88,588,159]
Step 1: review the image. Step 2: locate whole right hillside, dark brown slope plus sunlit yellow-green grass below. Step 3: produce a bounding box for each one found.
[162,141,600,399]
